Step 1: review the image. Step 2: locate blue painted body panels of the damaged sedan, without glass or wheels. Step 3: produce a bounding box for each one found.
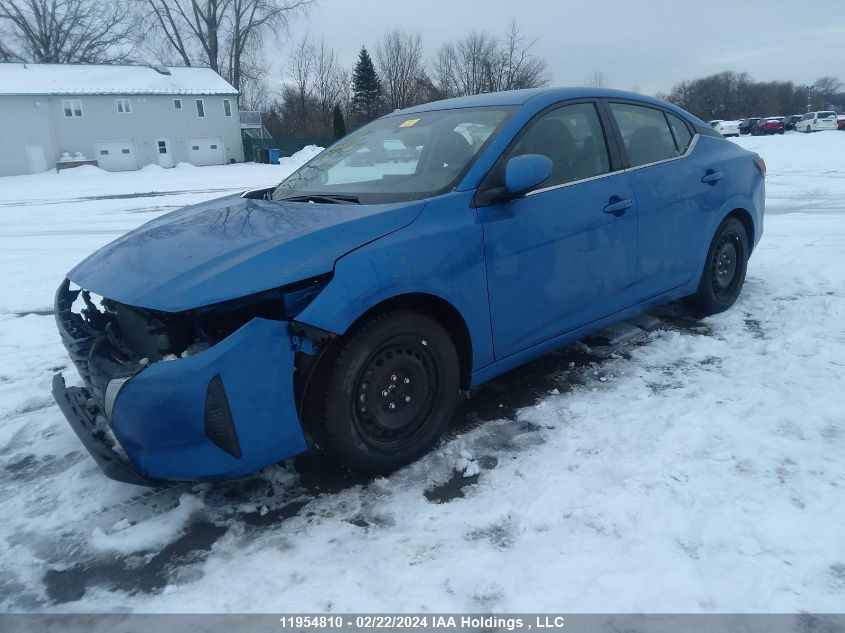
[56,88,764,479]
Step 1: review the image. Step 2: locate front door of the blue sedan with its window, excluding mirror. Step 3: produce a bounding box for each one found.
[478,102,637,360]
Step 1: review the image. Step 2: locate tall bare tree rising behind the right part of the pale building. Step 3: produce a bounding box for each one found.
[145,0,315,89]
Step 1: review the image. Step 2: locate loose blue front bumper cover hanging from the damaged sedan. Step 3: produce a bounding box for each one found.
[54,318,307,485]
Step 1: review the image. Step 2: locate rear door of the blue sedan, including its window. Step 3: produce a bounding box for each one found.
[608,102,729,300]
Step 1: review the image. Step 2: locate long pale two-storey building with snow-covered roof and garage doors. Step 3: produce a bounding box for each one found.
[0,63,244,176]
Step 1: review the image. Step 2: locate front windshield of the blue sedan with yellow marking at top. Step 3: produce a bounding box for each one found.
[272,107,514,204]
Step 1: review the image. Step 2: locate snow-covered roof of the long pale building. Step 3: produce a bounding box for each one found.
[0,63,238,95]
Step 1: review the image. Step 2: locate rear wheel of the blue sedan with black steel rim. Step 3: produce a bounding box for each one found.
[687,217,749,315]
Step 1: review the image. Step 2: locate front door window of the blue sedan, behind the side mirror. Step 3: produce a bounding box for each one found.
[505,103,610,187]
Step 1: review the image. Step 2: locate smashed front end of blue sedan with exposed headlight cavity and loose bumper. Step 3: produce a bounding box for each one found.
[53,275,334,485]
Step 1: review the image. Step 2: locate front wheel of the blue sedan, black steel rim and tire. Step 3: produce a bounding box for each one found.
[306,310,460,475]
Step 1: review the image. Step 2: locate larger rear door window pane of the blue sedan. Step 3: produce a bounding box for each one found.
[610,103,680,167]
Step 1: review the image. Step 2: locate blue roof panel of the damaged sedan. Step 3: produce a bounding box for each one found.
[387,87,675,116]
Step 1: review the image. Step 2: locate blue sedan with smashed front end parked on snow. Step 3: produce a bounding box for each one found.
[53,88,766,483]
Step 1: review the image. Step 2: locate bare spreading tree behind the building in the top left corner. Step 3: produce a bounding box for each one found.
[0,0,138,64]
